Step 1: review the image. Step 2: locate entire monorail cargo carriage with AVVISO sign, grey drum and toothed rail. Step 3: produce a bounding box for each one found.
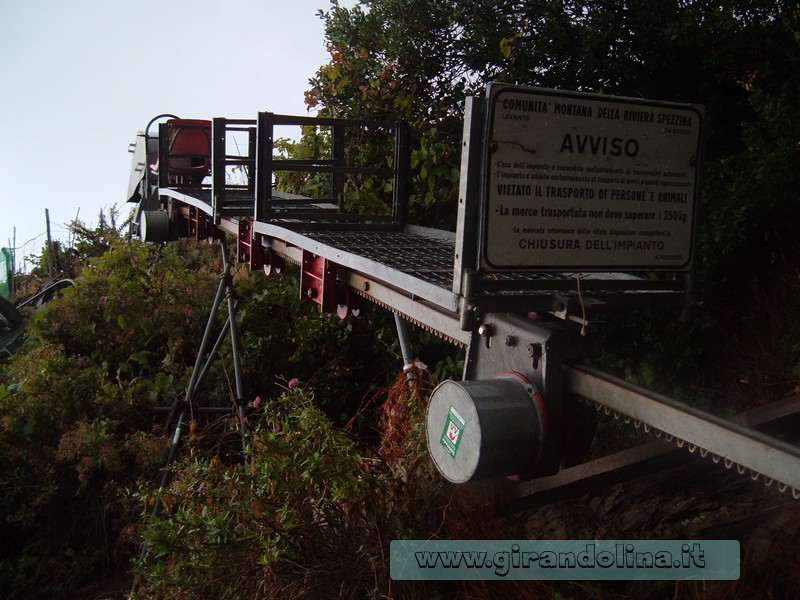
[128,85,800,491]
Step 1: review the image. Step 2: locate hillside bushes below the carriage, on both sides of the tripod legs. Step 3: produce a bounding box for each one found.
[0,231,556,599]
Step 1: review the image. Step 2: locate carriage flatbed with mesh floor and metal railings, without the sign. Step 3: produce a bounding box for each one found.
[131,106,687,344]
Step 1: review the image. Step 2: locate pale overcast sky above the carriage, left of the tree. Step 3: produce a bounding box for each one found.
[0,0,356,268]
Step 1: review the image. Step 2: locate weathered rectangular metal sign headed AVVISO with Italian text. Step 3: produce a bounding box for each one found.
[481,85,703,271]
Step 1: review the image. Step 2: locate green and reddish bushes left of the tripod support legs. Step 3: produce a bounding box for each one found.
[0,239,222,598]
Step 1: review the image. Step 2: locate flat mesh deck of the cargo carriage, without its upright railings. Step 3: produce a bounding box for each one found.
[162,189,683,339]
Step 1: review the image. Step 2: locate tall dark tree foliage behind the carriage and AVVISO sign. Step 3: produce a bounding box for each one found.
[306,0,800,404]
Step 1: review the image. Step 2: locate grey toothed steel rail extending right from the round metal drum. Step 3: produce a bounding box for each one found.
[565,367,800,499]
